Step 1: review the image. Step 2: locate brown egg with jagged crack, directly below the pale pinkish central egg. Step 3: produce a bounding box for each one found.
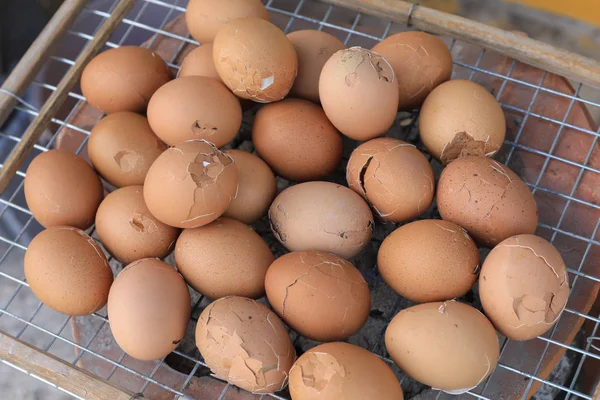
[265,250,371,342]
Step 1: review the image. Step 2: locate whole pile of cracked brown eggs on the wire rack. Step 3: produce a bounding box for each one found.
[24,0,569,400]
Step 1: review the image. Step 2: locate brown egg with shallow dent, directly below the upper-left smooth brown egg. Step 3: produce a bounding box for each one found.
[88,111,167,187]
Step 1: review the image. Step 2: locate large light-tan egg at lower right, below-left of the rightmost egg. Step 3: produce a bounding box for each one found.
[385,301,500,394]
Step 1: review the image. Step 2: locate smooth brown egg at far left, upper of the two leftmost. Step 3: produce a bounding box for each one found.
[24,150,104,229]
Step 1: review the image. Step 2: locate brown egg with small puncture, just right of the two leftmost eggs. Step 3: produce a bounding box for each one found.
[96,186,179,264]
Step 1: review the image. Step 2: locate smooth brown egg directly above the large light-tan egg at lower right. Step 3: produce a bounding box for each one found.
[377,219,479,303]
